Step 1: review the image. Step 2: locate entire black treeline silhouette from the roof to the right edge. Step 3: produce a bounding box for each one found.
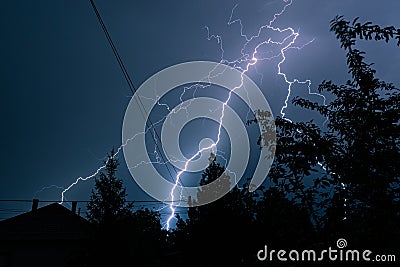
[78,17,400,266]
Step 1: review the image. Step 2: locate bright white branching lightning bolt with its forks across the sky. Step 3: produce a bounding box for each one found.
[35,0,325,230]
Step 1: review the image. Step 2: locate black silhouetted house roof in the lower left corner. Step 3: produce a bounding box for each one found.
[0,203,92,240]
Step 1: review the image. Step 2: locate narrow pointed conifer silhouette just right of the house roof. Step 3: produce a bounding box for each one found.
[87,150,133,266]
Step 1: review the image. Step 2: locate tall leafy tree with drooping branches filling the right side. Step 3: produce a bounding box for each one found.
[256,16,400,249]
